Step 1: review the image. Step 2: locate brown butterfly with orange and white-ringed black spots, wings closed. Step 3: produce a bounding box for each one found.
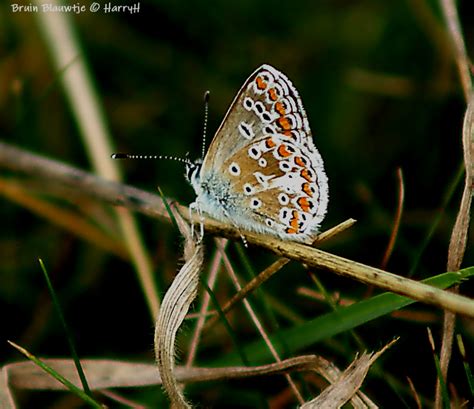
[186,64,329,242]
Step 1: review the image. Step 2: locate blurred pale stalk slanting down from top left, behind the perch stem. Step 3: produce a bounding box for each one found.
[35,0,160,318]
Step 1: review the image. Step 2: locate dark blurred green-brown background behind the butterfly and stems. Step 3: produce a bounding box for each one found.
[0,0,474,407]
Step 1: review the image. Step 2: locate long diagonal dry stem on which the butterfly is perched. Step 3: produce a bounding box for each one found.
[0,142,474,317]
